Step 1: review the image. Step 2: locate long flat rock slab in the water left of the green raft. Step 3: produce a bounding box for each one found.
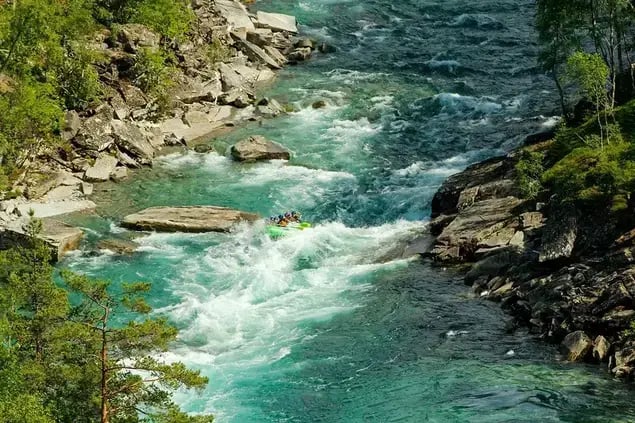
[121,206,260,233]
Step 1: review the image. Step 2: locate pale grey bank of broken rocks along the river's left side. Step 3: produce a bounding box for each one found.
[0,0,322,257]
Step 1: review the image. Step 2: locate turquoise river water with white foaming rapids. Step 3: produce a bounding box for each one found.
[62,0,635,422]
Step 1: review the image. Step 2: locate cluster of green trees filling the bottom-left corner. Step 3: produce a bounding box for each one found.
[0,218,212,423]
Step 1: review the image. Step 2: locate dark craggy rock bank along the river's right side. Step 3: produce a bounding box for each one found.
[425,139,635,379]
